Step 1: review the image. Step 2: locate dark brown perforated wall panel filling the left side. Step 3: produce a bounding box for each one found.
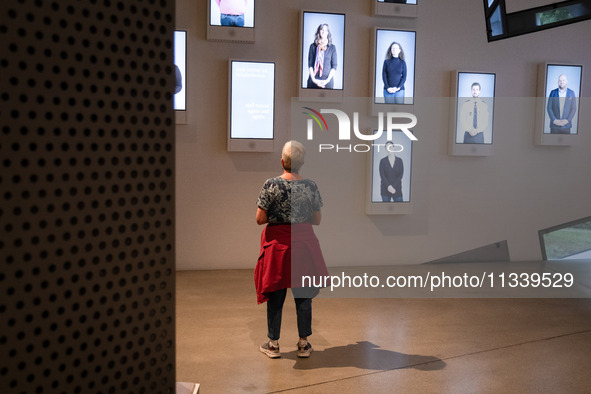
[0,0,175,394]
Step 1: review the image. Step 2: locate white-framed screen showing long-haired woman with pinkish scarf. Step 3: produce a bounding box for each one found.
[298,11,345,101]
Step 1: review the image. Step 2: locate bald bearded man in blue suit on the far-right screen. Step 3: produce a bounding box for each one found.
[546,74,577,134]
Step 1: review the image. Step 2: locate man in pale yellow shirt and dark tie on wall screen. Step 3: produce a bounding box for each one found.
[458,82,490,144]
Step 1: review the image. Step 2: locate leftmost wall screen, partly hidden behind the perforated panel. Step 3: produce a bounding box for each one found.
[173,30,187,124]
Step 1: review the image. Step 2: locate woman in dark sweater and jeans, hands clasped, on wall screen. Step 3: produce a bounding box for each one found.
[382,41,406,104]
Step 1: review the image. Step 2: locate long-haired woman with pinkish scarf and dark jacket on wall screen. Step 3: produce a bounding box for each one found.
[307,23,337,89]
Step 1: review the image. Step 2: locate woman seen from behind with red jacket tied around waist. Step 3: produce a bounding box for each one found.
[254,141,328,358]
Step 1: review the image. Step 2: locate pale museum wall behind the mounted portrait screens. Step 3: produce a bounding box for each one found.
[176,0,591,270]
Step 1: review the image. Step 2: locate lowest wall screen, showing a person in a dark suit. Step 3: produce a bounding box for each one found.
[366,131,412,215]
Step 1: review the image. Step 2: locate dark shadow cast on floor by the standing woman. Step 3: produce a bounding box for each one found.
[281,341,446,371]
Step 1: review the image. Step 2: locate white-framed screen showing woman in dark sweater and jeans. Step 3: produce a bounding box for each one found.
[370,28,416,115]
